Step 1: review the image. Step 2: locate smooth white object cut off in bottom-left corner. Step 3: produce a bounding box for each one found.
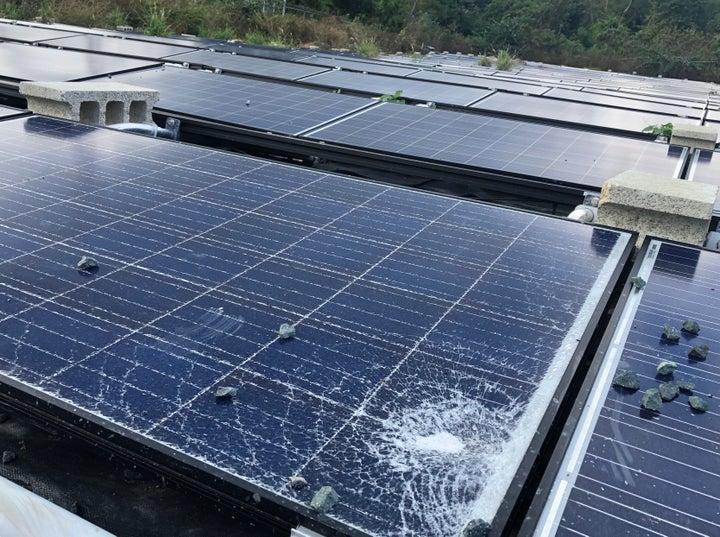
[0,477,113,537]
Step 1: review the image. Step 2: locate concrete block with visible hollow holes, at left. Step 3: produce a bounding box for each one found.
[20,82,160,125]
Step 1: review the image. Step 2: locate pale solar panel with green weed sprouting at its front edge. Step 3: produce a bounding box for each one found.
[296,71,492,106]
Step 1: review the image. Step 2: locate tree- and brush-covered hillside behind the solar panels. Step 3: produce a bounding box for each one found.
[5,0,720,81]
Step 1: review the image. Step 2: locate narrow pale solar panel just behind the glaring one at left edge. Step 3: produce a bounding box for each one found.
[43,35,192,59]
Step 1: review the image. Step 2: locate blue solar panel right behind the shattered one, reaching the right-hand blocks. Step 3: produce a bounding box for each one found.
[307,103,682,189]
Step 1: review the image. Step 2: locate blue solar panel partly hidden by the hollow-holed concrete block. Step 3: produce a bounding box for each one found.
[113,68,374,135]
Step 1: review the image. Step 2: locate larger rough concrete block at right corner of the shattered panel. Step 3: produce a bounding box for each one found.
[597,171,718,246]
